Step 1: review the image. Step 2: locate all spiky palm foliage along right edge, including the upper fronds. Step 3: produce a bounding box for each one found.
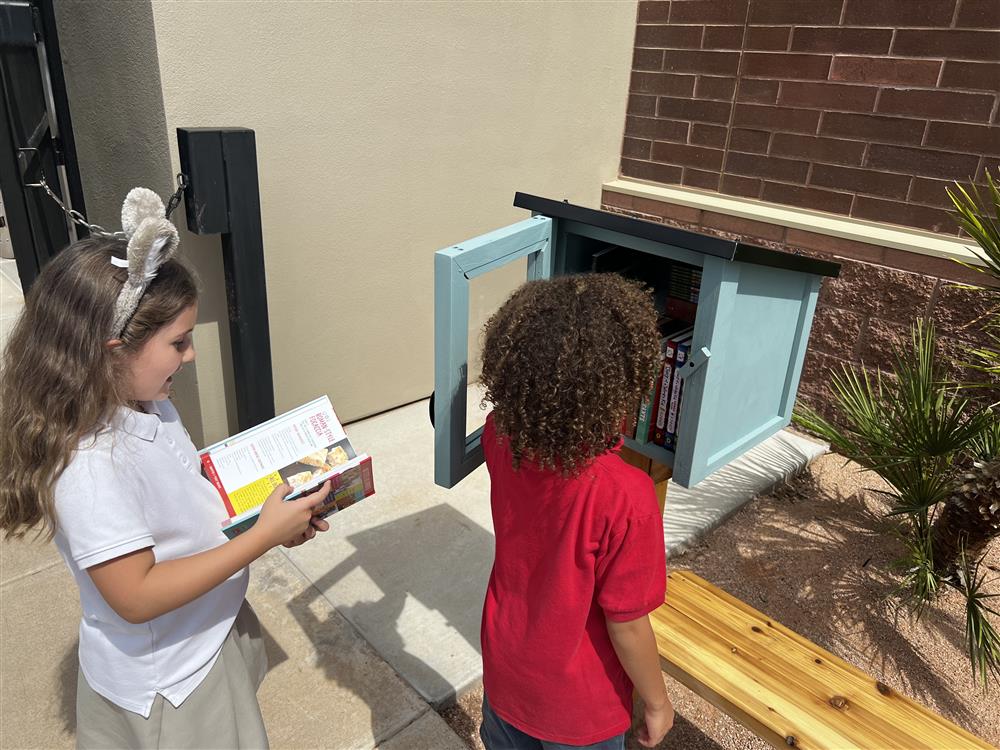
[795,173,1000,686]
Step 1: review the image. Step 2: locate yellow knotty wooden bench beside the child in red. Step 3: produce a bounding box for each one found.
[651,572,990,750]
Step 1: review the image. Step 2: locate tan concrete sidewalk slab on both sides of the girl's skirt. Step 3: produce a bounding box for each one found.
[0,542,464,750]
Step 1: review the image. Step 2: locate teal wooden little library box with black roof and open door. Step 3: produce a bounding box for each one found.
[431,193,840,487]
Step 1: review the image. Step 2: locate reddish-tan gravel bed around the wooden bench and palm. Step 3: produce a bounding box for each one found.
[442,455,1000,750]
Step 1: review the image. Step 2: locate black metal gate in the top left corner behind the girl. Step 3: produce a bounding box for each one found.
[0,0,86,291]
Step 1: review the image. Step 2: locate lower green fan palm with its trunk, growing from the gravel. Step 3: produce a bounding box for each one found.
[795,322,1000,685]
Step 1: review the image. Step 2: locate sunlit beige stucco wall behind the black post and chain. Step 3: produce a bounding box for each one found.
[146,0,635,440]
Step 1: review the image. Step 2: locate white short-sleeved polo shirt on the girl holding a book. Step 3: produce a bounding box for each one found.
[55,401,249,717]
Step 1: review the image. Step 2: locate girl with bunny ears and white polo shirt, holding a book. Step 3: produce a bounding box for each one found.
[0,188,329,748]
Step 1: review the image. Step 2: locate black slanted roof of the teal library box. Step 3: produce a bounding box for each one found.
[514,193,840,277]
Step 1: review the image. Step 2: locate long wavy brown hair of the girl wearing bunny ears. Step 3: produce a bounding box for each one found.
[0,238,198,538]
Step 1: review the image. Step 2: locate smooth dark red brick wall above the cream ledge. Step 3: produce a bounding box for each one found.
[621,0,1000,233]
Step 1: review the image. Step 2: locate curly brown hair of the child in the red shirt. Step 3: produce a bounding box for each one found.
[481,273,659,475]
